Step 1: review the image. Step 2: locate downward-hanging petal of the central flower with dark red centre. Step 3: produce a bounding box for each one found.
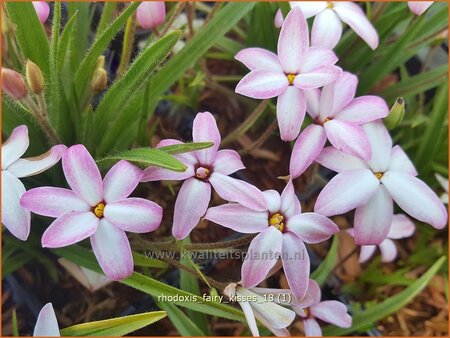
[172,178,211,240]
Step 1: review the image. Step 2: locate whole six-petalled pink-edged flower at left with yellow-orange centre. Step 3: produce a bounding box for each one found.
[21,144,163,280]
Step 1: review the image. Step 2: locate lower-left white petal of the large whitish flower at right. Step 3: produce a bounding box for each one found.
[314,169,380,216]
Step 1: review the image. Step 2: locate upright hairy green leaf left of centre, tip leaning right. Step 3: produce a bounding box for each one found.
[95,31,181,153]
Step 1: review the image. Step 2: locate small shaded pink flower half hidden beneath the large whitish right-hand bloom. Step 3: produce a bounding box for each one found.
[347,214,416,263]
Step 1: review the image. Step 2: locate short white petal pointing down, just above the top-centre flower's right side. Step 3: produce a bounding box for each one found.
[311,9,342,49]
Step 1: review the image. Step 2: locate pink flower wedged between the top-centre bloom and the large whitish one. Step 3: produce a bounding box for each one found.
[289,72,389,178]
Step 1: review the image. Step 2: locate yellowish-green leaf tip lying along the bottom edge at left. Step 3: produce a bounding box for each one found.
[61,311,167,337]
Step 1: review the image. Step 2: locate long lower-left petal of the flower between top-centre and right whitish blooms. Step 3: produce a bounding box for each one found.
[289,124,327,178]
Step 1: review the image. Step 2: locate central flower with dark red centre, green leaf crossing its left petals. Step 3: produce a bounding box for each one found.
[142,112,265,239]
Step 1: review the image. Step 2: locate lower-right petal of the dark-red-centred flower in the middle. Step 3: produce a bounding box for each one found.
[209,172,267,211]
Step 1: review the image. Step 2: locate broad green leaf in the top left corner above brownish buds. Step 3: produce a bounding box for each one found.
[5,1,49,75]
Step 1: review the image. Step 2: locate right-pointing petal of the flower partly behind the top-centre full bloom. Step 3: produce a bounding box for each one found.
[335,95,389,124]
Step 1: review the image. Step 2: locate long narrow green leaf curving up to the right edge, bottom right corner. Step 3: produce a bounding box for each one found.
[322,257,447,336]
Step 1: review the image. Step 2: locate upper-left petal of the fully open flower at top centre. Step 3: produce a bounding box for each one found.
[234,48,283,73]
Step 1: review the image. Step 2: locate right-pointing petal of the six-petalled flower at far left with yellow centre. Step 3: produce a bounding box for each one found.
[104,197,163,233]
